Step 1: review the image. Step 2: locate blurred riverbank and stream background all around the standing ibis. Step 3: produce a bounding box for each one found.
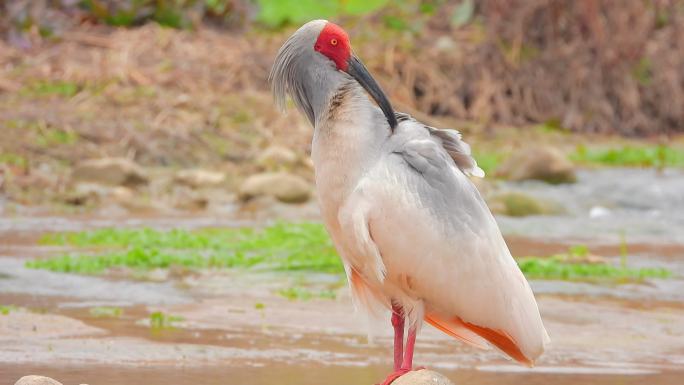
[0,0,684,385]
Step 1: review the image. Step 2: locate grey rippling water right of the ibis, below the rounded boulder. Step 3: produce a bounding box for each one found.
[497,168,684,244]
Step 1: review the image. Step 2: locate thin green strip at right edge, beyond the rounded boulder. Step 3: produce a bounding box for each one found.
[570,145,684,167]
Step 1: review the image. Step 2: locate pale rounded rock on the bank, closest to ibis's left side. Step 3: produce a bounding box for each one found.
[238,172,311,203]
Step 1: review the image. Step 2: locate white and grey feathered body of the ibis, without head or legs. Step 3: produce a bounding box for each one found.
[312,87,548,362]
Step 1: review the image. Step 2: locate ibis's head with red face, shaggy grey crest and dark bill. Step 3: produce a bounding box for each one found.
[269,20,397,128]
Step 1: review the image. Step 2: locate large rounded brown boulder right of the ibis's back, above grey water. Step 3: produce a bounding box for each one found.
[496,146,577,184]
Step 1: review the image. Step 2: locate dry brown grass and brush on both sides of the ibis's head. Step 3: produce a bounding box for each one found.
[0,0,684,206]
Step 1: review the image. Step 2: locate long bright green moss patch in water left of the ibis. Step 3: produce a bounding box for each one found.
[31,223,343,274]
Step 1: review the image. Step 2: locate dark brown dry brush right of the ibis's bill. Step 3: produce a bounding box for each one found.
[372,0,684,135]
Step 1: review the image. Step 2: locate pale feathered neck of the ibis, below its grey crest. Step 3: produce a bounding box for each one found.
[311,80,389,220]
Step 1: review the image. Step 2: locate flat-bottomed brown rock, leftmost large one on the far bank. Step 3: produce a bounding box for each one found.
[71,158,149,186]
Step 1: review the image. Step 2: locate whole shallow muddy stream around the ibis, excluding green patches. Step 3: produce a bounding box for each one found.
[0,170,684,385]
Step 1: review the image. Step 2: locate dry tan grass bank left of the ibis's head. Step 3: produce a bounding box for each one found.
[0,24,310,202]
